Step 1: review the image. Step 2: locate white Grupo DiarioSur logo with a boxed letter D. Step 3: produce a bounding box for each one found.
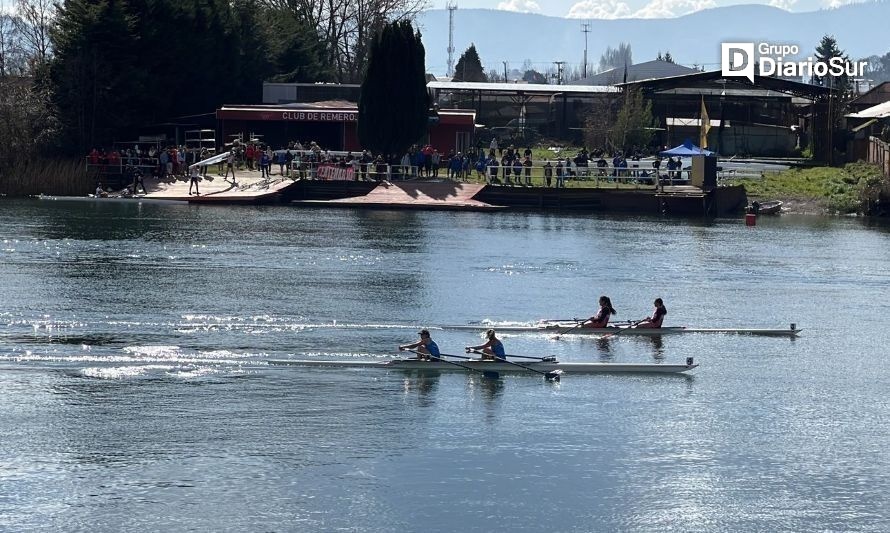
[720,43,868,83]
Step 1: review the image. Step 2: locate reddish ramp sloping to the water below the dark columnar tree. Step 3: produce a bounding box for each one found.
[293,181,503,211]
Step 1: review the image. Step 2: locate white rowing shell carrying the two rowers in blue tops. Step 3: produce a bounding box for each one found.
[268,359,698,374]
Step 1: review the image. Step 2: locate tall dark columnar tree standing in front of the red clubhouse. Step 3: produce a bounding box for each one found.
[358,21,430,158]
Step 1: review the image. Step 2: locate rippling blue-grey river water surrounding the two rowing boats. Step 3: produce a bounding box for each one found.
[0,200,890,532]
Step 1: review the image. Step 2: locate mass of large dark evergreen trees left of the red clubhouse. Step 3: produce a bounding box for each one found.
[50,0,278,151]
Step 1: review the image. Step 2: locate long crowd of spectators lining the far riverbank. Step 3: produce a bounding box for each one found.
[87,138,683,194]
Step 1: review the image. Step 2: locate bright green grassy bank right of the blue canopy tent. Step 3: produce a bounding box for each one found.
[734,162,887,214]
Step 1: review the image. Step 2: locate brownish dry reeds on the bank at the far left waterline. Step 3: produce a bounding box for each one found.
[0,159,96,196]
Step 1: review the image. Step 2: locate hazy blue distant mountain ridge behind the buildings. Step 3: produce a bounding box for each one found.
[418,1,890,75]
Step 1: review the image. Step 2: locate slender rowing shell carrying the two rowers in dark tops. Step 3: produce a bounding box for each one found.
[442,323,803,337]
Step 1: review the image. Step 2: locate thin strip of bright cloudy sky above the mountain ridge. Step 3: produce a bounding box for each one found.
[431,0,856,19]
